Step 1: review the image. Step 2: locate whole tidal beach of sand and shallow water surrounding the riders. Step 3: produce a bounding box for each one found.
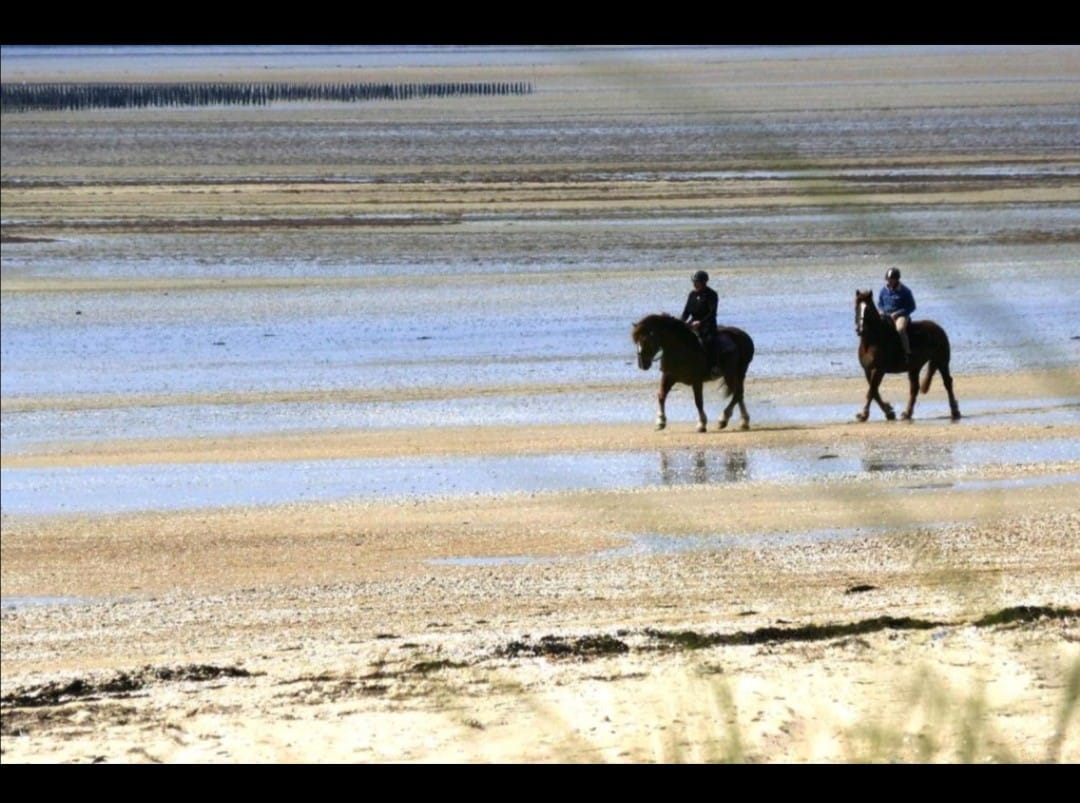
[0,49,1080,764]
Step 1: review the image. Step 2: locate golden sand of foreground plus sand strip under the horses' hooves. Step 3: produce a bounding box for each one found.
[2,369,1080,763]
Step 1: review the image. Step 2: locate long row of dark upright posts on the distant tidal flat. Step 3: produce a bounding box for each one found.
[0,81,532,112]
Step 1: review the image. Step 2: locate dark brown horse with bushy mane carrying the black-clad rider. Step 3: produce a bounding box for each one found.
[631,314,754,432]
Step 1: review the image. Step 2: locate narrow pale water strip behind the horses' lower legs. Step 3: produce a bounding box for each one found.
[0,397,1080,454]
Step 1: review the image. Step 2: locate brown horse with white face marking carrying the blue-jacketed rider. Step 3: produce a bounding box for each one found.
[855,290,960,421]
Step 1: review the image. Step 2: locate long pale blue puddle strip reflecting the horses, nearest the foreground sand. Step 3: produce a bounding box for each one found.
[0,438,1080,515]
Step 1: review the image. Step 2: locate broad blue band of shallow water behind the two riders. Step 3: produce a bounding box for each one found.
[0,260,1080,398]
